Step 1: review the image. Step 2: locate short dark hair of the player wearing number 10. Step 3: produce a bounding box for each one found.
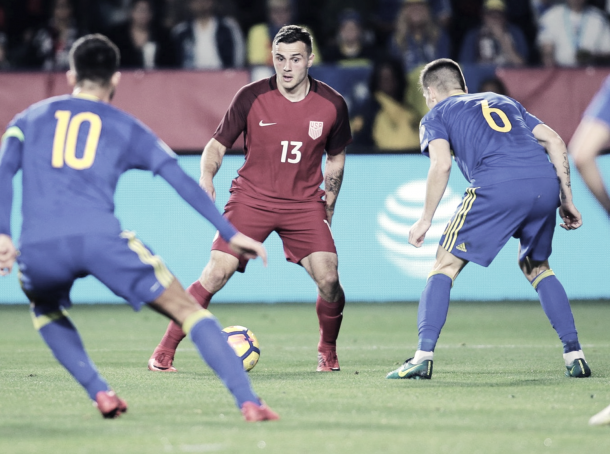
[70,33,120,85]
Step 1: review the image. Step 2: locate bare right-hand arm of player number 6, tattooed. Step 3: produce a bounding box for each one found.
[532,123,582,230]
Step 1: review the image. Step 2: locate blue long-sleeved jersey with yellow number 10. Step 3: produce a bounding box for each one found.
[0,95,235,244]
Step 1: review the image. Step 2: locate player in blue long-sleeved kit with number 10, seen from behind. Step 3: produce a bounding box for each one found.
[0,35,278,421]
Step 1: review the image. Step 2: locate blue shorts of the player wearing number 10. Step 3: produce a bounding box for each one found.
[18,231,174,310]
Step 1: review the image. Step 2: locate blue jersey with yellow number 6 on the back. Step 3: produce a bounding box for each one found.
[420,93,557,186]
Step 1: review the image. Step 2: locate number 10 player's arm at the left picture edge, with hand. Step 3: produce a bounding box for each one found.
[0,126,23,276]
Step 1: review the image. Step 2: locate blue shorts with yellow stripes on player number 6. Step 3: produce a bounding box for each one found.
[439,178,559,266]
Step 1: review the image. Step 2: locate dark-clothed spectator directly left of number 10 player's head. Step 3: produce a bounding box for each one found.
[21,0,83,71]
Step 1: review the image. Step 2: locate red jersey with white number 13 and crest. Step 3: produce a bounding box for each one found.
[213,76,352,205]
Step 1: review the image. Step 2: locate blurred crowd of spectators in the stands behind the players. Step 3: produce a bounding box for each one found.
[0,0,610,150]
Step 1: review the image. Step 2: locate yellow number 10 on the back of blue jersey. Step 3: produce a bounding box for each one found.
[51,110,102,170]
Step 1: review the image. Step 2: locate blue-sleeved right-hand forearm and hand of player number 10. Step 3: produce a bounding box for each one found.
[157,159,267,265]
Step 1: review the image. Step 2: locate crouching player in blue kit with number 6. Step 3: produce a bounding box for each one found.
[387,59,591,379]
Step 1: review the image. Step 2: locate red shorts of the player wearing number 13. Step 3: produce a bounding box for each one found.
[212,200,337,273]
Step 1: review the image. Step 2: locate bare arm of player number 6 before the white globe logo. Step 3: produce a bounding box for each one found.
[409,139,452,247]
